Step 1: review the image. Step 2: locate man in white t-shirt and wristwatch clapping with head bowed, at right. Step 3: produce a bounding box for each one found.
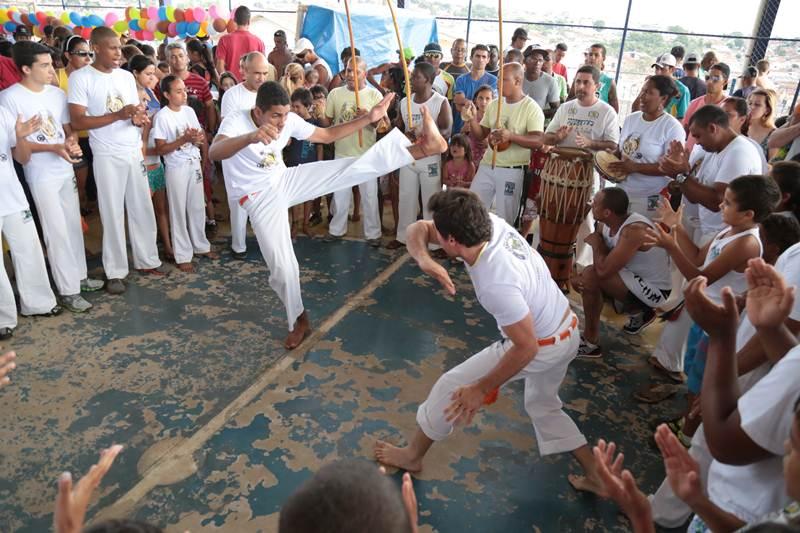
[651,105,761,374]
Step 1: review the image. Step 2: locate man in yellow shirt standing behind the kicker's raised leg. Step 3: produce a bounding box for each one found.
[320,57,382,248]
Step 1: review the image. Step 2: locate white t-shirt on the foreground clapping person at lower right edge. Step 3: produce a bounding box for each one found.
[708,346,800,522]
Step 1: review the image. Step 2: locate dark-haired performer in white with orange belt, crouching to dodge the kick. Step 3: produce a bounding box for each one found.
[375,188,603,493]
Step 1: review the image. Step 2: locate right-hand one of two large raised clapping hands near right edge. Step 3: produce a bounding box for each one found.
[745,258,795,328]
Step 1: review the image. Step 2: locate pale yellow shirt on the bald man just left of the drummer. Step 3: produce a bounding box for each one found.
[481,96,544,167]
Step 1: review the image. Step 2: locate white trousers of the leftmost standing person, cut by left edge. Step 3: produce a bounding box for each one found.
[0,210,56,328]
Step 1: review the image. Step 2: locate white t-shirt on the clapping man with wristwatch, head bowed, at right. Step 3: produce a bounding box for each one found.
[689,135,763,234]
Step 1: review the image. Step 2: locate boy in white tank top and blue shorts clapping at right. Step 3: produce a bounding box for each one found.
[645,176,780,446]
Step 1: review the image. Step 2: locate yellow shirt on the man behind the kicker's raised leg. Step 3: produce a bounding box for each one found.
[325,86,383,158]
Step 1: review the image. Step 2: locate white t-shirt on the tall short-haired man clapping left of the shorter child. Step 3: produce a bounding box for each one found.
[67,65,142,155]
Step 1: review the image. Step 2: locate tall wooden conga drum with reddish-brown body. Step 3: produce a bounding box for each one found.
[538,148,594,290]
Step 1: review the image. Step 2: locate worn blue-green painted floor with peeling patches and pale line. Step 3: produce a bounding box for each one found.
[0,239,678,532]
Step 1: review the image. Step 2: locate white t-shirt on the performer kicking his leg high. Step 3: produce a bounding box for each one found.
[217,111,316,200]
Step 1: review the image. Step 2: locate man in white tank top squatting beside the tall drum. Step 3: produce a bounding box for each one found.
[573,187,672,358]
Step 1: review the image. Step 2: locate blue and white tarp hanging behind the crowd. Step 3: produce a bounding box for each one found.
[300,5,439,72]
